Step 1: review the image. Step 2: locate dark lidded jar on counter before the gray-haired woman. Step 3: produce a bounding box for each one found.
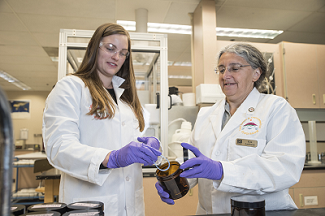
[231,195,265,216]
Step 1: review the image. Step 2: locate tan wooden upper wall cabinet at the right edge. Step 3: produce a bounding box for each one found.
[281,42,325,108]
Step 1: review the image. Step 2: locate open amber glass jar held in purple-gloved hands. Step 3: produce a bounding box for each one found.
[156,161,190,200]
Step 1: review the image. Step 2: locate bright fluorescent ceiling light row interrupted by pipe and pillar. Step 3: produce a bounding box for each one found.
[117,20,283,39]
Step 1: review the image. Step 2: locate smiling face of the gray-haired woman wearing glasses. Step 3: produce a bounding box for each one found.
[218,53,260,104]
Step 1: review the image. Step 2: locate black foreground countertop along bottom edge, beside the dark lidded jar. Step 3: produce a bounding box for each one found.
[195,208,325,216]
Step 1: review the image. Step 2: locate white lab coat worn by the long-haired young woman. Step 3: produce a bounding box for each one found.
[43,76,145,216]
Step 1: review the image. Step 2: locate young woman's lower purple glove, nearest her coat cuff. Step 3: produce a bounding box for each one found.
[107,141,161,168]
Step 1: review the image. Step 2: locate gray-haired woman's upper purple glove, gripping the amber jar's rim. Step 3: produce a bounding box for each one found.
[179,143,223,180]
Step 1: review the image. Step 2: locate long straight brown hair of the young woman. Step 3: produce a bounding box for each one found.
[73,23,144,131]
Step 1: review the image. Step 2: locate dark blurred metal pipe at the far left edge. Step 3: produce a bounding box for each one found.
[0,88,13,216]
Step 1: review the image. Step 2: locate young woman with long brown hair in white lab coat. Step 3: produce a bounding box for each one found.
[43,23,161,216]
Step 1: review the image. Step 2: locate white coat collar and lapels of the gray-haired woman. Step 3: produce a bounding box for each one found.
[213,88,260,139]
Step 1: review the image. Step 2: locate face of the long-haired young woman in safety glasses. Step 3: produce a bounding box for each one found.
[97,34,128,87]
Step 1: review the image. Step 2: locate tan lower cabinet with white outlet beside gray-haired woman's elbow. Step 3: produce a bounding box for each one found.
[289,169,325,209]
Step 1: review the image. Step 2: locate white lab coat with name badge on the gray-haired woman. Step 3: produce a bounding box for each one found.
[190,88,306,214]
